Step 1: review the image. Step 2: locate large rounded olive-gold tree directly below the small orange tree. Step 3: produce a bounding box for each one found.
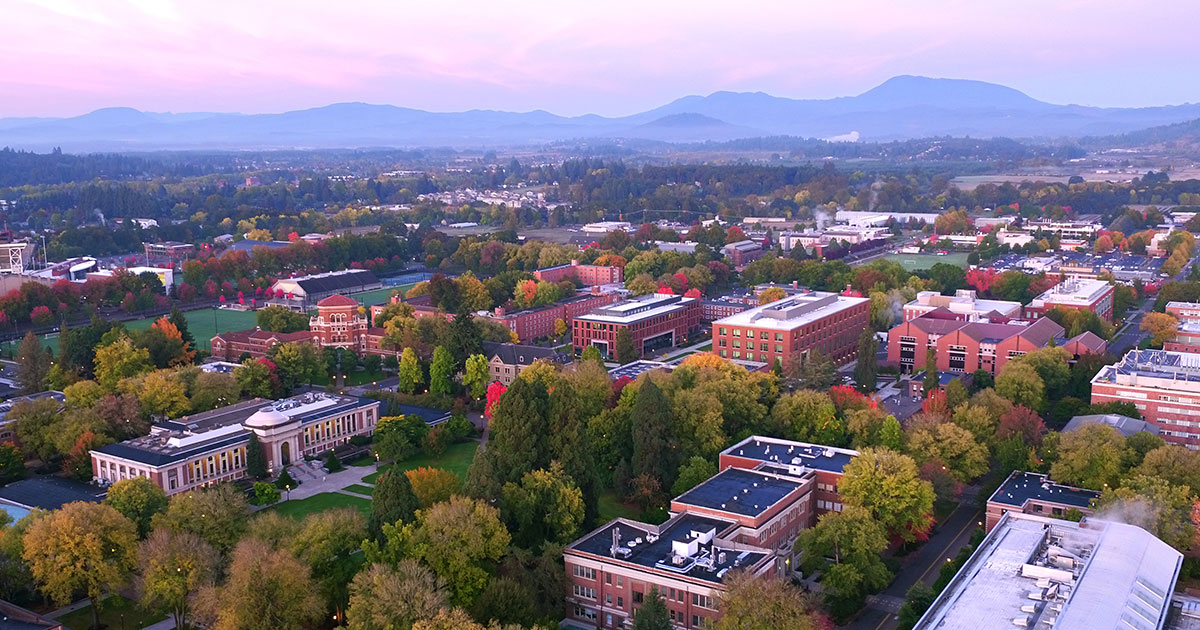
[388,497,511,606]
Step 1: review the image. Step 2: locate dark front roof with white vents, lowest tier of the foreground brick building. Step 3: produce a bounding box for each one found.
[566,512,770,584]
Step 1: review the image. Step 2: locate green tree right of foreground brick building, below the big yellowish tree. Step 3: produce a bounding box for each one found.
[796,505,892,601]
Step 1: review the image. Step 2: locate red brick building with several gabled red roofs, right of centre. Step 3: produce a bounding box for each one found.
[888,312,1106,376]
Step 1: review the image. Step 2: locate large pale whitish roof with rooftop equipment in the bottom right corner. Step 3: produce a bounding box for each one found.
[916,512,1183,630]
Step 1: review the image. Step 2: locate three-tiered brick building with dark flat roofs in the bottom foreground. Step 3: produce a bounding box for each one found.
[563,437,857,630]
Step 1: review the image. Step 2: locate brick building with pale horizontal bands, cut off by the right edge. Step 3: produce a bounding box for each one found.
[1092,349,1200,450]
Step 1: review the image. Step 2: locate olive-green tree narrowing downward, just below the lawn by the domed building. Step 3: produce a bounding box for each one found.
[292,508,367,618]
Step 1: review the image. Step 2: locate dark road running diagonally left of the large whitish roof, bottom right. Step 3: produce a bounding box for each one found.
[841,496,983,630]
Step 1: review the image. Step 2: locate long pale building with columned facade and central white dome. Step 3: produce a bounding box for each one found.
[91,392,379,494]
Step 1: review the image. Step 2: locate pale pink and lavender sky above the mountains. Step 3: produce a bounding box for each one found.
[0,0,1200,116]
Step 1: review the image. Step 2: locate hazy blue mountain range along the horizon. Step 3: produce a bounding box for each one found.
[0,76,1200,151]
